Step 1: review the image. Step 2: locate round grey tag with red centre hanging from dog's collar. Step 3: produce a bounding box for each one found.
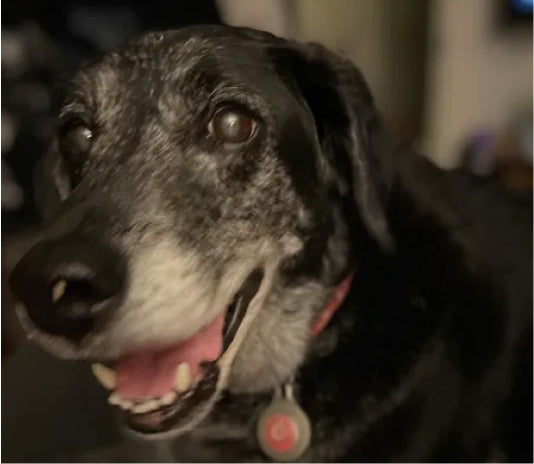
[256,398,311,462]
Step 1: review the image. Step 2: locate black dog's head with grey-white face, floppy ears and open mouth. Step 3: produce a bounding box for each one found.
[7,26,391,434]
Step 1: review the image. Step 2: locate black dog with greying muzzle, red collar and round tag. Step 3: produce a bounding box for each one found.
[10,26,532,462]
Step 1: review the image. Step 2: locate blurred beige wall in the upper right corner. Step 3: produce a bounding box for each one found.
[423,0,532,168]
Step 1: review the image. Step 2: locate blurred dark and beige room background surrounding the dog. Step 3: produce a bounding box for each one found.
[1,0,533,461]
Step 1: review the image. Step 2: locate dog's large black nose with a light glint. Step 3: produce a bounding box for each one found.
[10,236,126,341]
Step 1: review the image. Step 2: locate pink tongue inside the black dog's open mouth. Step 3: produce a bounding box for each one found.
[116,313,224,400]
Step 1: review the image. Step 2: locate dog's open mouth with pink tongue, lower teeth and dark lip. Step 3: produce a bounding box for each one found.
[92,269,263,436]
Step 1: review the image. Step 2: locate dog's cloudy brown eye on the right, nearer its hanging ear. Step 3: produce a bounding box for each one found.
[209,108,256,144]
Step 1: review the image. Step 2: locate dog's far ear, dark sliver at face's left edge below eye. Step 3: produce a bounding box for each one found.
[33,141,70,220]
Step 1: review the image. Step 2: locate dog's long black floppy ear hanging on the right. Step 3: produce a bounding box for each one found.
[275,43,394,250]
